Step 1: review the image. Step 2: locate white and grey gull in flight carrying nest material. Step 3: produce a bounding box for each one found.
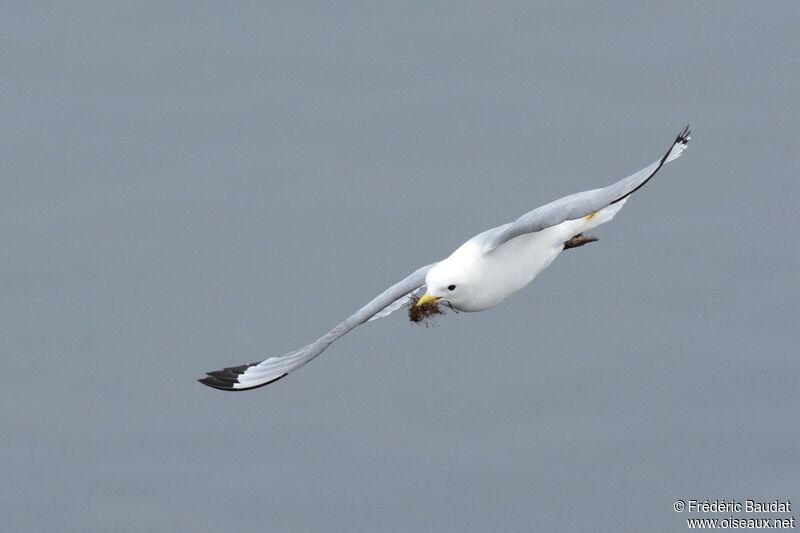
[198,126,690,391]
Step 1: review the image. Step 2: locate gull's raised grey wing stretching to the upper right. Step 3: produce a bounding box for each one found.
[475,126,691,251]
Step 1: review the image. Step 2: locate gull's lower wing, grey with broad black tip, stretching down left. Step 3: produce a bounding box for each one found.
[198,263,436,391]
